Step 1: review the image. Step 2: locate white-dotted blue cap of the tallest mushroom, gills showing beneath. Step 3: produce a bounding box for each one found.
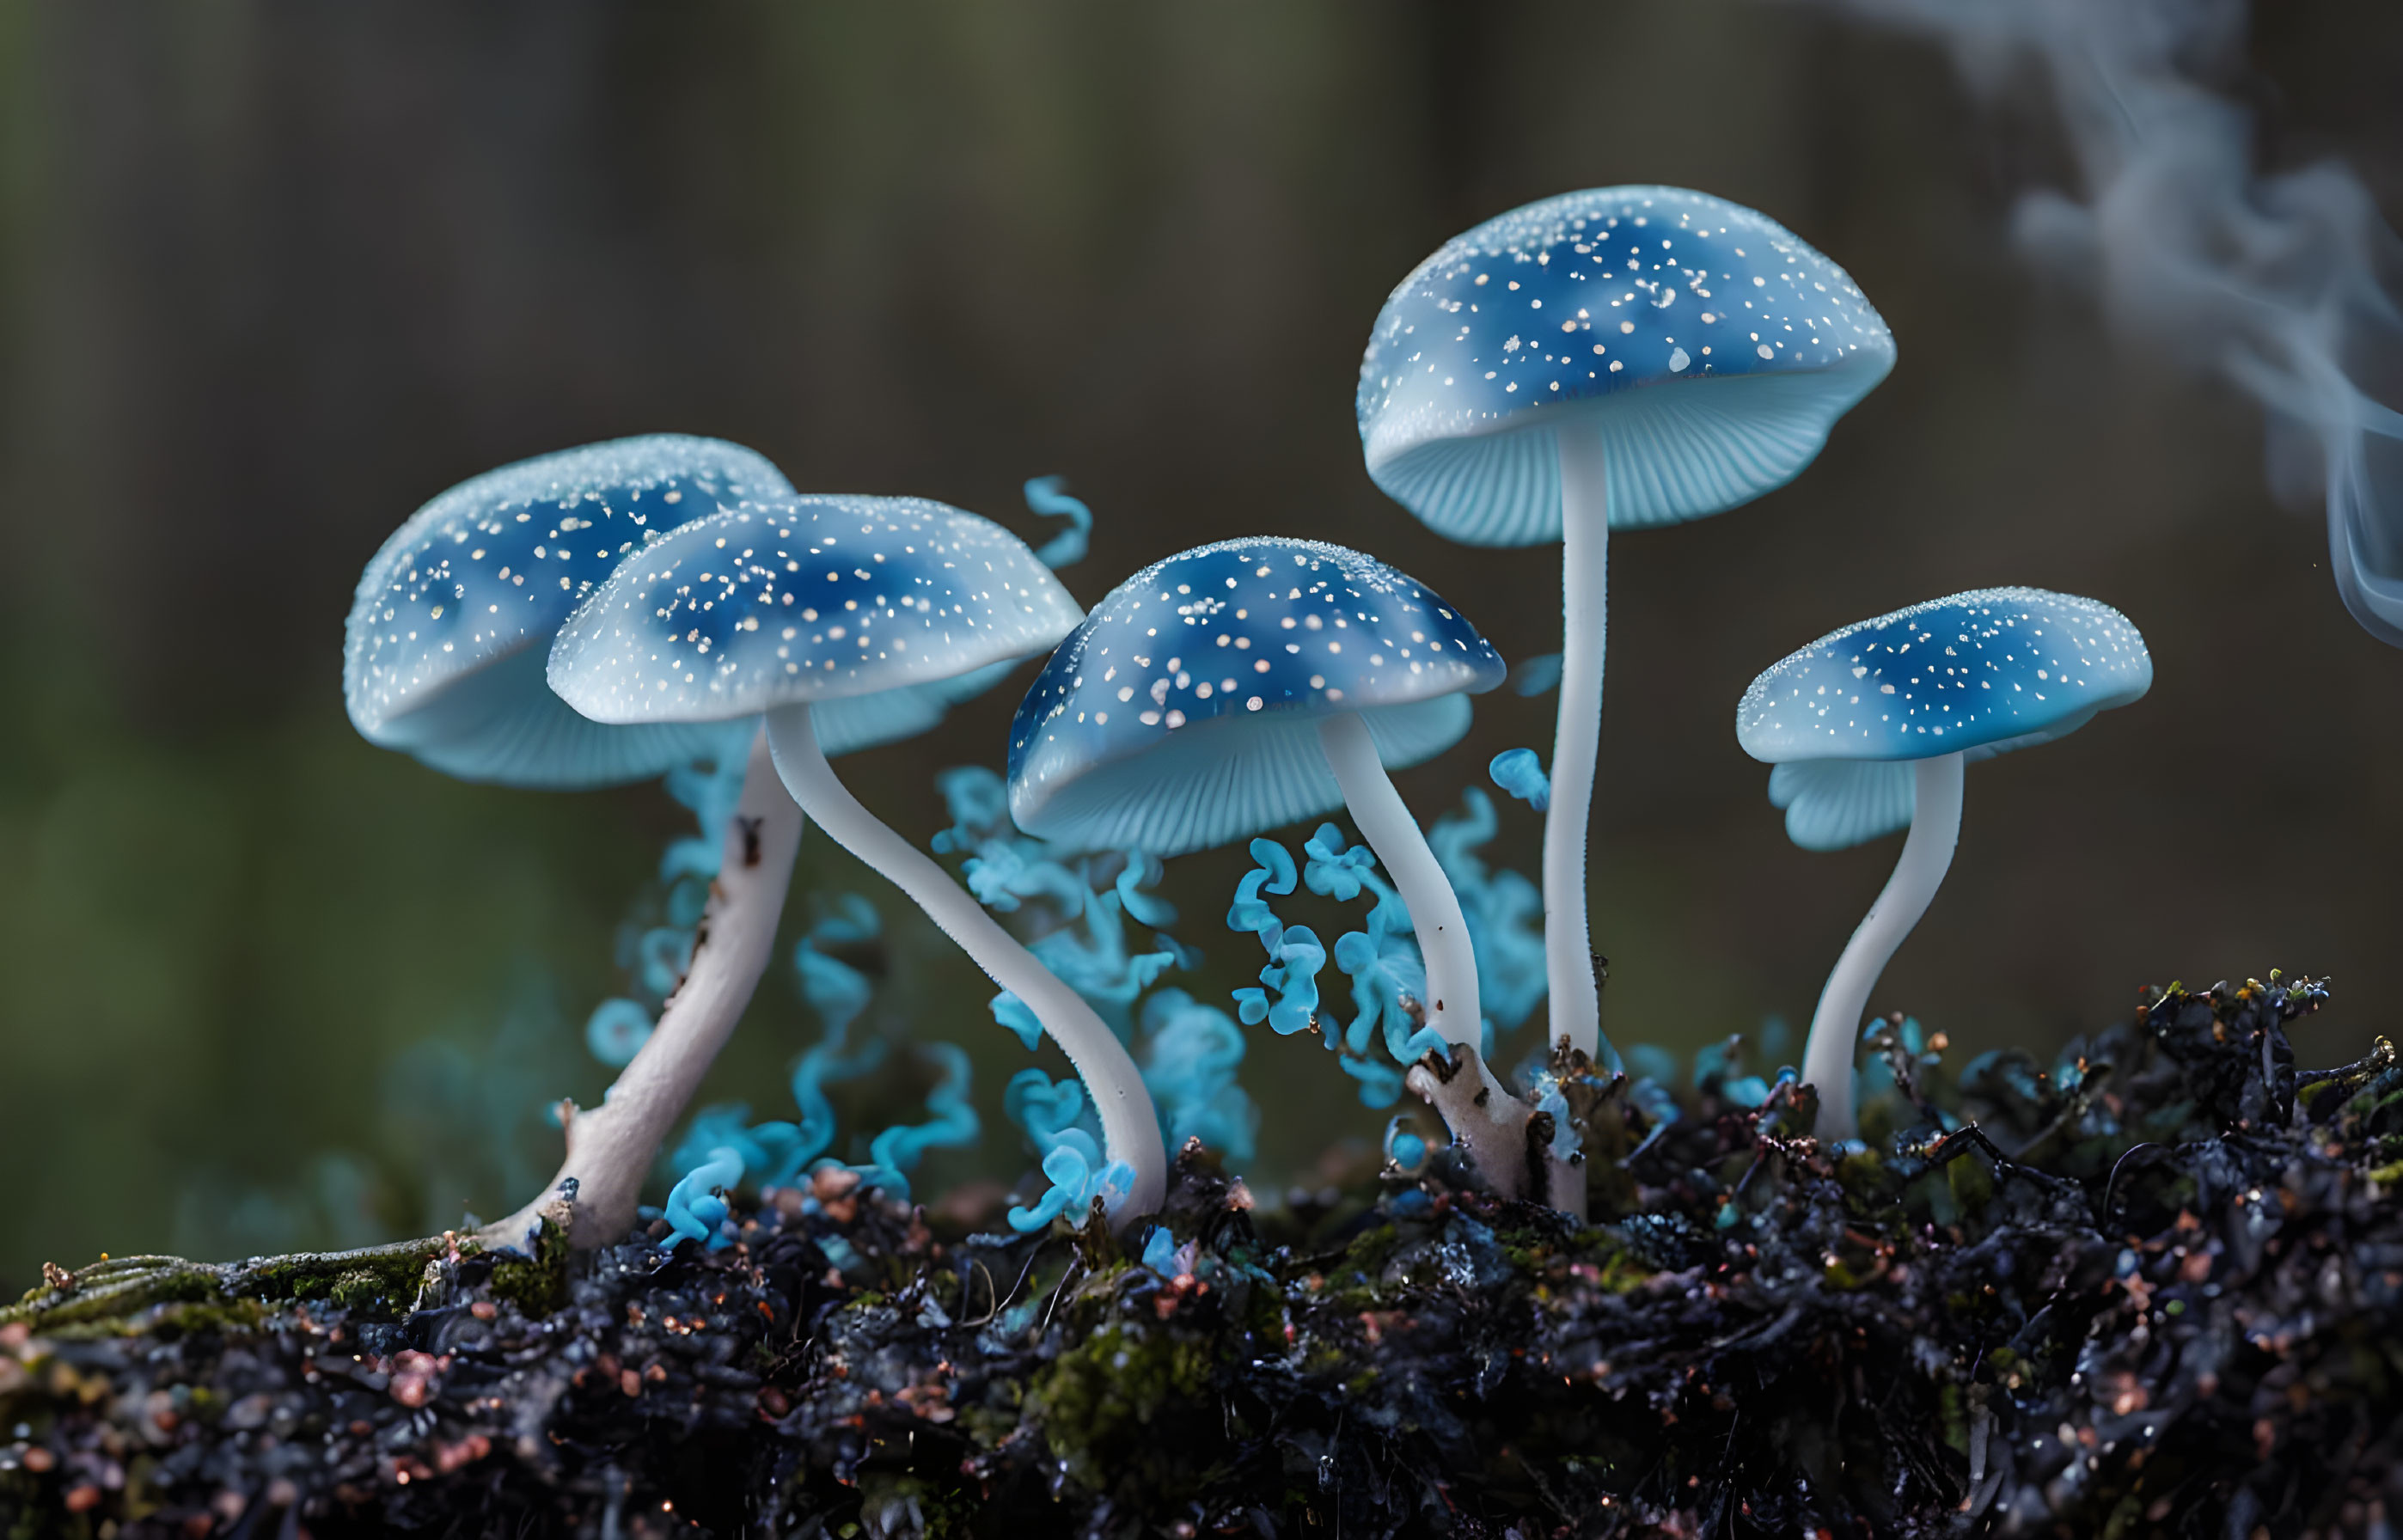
[1355,187,1893,546]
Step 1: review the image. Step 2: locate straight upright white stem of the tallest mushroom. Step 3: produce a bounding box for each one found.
[1543,418,1620,1069]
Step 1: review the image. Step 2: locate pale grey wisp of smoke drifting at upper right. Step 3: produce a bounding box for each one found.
[1829,0,2403,646]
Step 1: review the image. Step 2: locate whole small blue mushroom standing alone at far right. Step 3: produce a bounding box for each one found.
[1735,589,2153,1139]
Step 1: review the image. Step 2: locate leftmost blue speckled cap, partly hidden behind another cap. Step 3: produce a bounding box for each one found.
[341,435,791,788]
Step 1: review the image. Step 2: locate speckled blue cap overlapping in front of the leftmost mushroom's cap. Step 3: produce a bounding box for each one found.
[550,495,1079,730]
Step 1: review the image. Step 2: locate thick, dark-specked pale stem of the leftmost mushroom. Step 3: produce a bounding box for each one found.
[483,730,803,1250]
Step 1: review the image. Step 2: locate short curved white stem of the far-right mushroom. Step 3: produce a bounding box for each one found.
[1802,755,1961,1139]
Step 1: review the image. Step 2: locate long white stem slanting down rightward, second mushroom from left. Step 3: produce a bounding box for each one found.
[767,704,1168,1225]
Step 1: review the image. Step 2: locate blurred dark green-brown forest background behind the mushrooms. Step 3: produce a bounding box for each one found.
[0,0,2403,1292]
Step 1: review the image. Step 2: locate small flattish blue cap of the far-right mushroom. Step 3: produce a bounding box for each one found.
[1735,589,2153,851]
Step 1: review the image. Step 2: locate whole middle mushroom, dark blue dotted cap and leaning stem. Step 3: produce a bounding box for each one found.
[1009,535,1566,1194]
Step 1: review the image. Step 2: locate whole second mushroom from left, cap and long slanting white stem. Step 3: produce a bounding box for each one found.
[550,498,1165,1223]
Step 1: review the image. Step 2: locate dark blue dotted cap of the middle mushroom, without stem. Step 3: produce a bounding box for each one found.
[1009,535,1507,855]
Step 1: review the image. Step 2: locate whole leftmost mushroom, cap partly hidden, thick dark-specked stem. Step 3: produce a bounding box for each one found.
[344,435,800,1247]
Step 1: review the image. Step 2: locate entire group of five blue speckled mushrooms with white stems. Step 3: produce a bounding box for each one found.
[344,187,2150,1247]
